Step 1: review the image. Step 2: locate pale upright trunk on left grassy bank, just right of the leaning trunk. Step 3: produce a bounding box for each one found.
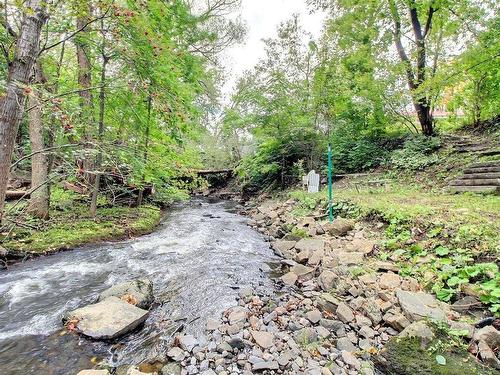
[28,66,49,219]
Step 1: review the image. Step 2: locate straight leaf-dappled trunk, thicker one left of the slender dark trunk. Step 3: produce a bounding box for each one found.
[75,2,95,184]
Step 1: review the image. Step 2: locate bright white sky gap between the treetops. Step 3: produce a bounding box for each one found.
[223,0,324,94]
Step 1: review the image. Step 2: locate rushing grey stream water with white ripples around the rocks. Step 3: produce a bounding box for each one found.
[0,199,276,375]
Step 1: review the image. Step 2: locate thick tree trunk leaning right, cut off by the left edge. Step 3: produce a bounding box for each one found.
[0,0,47,222]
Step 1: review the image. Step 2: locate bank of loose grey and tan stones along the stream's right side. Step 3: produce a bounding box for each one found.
[76,200,500,375]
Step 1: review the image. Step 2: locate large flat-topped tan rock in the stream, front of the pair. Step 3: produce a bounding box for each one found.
[65,297,148,340]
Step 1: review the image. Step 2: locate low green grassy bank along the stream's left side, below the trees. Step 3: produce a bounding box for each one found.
[0,202,161,254]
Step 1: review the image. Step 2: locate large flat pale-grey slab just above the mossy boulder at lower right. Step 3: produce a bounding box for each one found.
[396,290,446,321]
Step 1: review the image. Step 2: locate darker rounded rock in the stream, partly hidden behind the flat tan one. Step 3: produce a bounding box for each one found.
[98,279,154,309]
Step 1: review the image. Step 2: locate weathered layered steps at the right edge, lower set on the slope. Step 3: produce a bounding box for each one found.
[448,160,500,195]
